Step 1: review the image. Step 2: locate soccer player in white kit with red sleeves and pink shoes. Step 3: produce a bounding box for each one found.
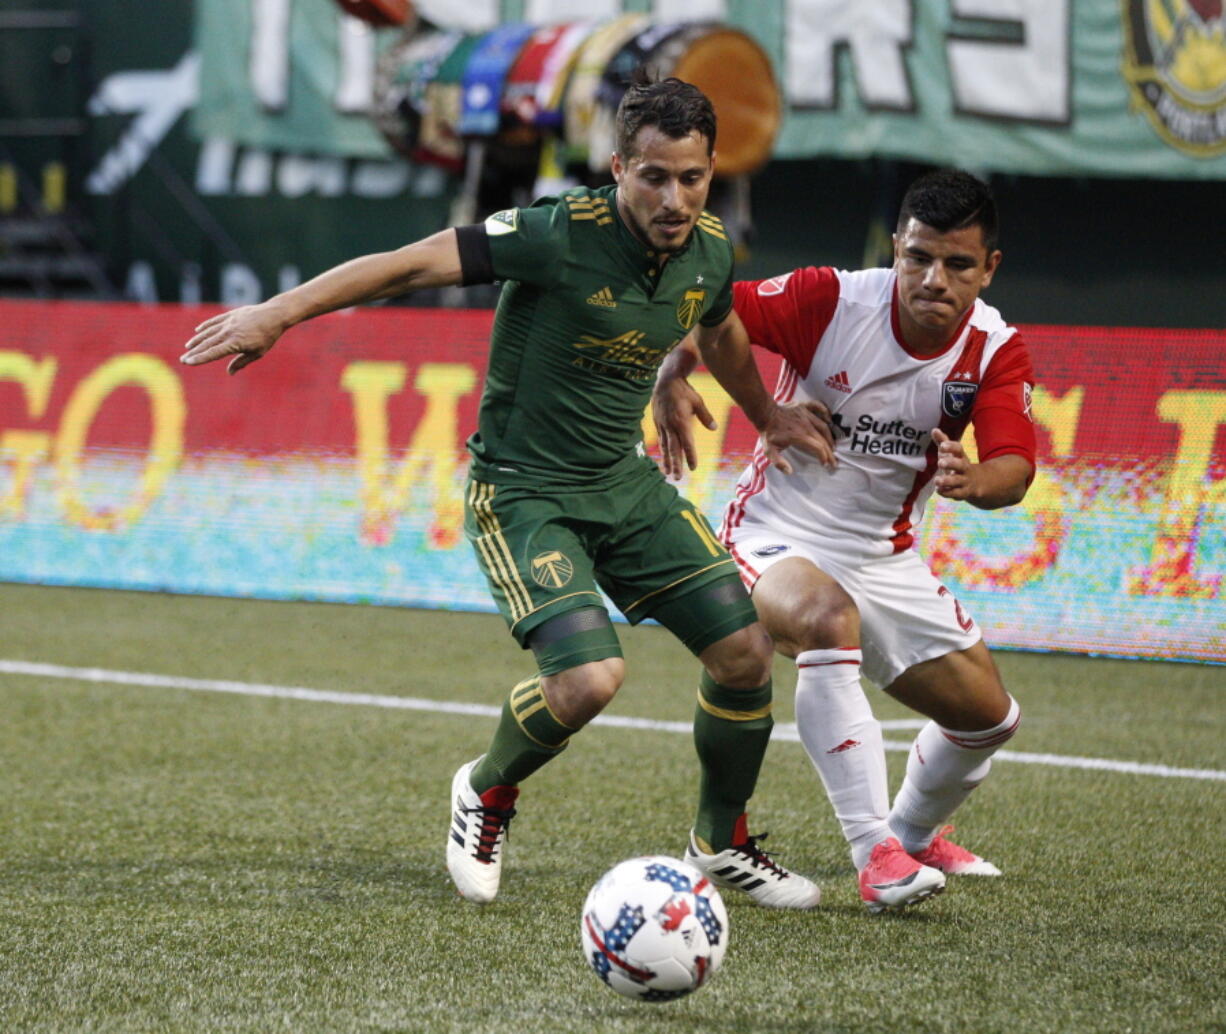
[653,170,1035,913]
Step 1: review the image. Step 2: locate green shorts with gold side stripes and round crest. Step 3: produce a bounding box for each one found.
[465,461,736,645]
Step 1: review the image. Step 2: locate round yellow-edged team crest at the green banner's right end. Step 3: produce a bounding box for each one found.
[1124,0,1226,157]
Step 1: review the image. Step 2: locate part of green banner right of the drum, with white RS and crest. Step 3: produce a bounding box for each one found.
[760,0,1226,179]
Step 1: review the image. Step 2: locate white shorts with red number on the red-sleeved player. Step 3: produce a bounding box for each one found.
[725,523,983,688]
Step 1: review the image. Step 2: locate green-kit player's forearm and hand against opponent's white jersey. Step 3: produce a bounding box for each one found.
[695,309,837,473]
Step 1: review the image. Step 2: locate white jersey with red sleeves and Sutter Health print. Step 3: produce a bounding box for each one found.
[721,266,1035,557]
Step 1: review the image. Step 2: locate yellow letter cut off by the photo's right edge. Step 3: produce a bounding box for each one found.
[1128,391,1226,600]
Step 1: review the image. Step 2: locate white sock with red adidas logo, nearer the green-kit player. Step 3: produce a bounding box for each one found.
[796,648,890,868]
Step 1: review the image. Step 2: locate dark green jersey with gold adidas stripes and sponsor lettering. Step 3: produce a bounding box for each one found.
[468,186,732,484]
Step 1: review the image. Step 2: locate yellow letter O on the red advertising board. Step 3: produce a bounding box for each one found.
[55,352,188,531]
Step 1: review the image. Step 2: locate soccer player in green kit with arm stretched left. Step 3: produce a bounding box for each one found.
[183,77,832,908]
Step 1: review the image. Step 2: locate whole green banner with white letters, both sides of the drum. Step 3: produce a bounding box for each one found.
[195,0,1226,179]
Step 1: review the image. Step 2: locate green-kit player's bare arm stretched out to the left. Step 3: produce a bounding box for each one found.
[179,229,461,373]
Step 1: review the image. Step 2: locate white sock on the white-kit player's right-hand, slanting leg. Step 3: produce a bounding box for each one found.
[889,697,1021,854]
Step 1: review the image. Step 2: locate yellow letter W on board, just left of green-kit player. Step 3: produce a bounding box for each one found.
[341,362,477,550]
